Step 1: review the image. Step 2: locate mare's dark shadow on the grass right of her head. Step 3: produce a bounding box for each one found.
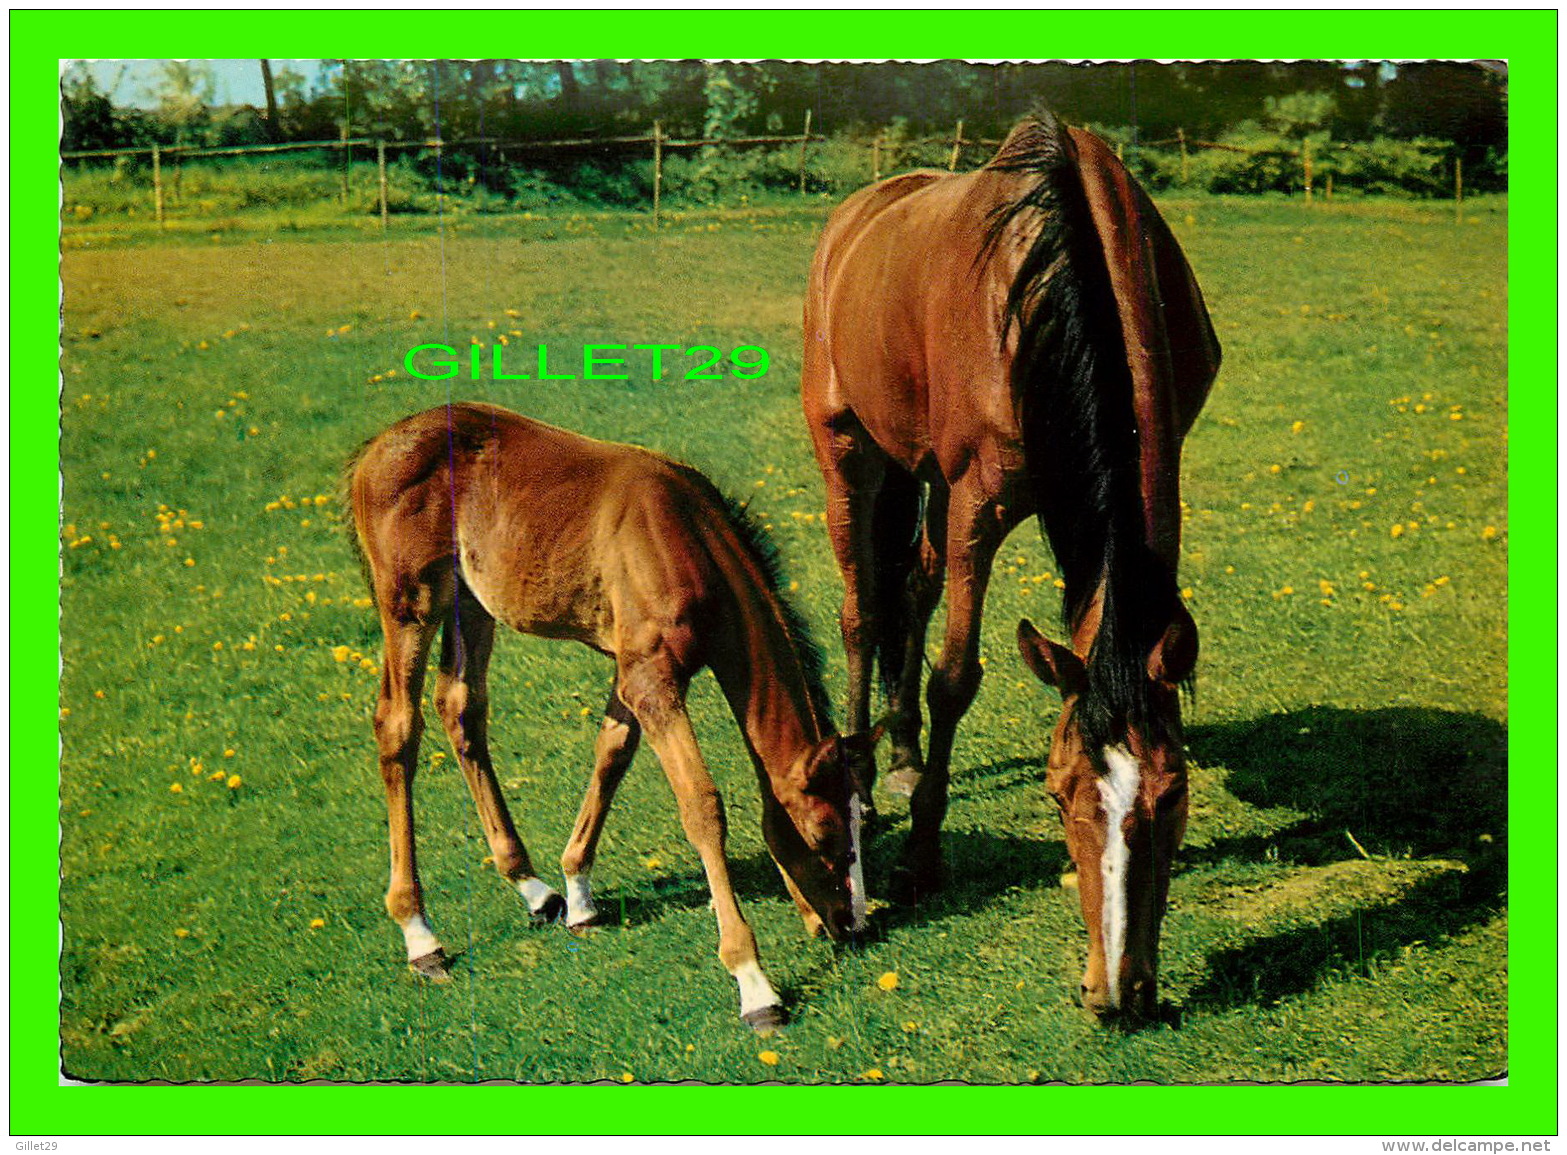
[1180,707,1507,1011]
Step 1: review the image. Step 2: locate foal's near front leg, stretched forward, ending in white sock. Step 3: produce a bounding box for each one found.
[621,663,784,1033]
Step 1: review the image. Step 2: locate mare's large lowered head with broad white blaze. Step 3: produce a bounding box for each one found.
[1017,606,1197,1017]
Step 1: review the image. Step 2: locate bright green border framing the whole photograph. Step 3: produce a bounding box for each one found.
[9,11,1558,1136]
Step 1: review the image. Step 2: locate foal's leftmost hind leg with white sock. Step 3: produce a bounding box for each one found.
[376,599,447,981]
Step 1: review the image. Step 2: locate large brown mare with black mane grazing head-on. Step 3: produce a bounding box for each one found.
[802,114,1219,1014]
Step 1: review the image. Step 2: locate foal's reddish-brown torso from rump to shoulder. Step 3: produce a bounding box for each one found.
[351,403,716,654]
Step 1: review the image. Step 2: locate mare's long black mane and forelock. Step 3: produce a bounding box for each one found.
[986,113,1178,748]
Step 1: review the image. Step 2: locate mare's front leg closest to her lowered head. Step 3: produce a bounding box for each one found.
[895,487,1001,901]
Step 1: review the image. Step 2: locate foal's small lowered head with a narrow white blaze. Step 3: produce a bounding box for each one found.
[762,730,881,942]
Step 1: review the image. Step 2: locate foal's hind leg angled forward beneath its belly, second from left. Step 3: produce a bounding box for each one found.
[436,583,566,921]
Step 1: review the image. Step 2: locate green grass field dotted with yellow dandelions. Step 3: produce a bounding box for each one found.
[61,191,1507,1083]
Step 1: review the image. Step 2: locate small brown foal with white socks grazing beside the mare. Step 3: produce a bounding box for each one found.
[348,404,874,1030]
